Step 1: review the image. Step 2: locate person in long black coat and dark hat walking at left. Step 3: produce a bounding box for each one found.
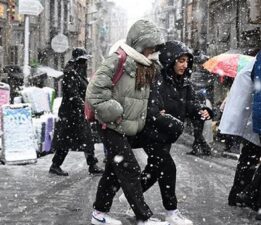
[49,48,103,176]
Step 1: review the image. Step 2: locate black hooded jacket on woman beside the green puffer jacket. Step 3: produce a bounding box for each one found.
[140,41,211,142]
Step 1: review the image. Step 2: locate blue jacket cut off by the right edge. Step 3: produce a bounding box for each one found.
[251,51,261,134]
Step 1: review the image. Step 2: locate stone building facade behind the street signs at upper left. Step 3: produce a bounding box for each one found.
[0,0,90,74]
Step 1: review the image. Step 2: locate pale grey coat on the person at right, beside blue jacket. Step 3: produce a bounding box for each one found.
[219,60,260,146]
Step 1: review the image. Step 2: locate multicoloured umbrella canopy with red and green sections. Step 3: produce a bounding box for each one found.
[203,53,254,77]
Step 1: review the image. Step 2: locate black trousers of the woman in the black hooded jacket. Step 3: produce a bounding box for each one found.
[141,143,177,210]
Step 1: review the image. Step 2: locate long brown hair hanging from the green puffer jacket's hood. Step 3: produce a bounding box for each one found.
[135,62,156,90]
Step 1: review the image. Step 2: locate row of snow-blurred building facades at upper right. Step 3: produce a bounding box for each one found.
[149,0,261,55]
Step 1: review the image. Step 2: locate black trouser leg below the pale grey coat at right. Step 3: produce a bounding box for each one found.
[228,140,261,202]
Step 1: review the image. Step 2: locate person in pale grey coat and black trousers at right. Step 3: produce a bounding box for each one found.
[216,50,261,216]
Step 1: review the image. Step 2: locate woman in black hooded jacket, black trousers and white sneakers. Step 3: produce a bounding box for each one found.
[125,41,212,225]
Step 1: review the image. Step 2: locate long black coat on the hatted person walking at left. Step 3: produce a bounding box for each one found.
[52,60,94,153]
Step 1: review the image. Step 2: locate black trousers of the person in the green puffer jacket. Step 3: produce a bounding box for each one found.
[93,129,152,221]
